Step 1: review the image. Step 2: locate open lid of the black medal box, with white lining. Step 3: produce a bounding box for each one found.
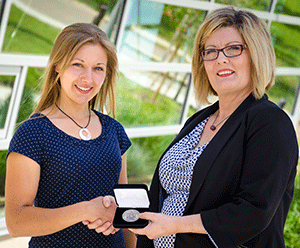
[114,184,150,208]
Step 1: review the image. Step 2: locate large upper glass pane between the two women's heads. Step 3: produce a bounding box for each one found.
[119,0,204,63]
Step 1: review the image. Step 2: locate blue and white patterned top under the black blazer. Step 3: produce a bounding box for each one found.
[154,117,209,248]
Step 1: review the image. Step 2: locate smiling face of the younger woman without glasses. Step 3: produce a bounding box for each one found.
[56,44,107,105]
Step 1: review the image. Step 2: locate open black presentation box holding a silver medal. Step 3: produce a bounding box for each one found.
[113,184,150,228]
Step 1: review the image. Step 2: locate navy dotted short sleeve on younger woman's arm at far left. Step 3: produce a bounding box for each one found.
[7,119,42,164]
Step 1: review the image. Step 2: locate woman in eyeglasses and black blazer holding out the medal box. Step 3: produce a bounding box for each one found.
[131,7,298,248]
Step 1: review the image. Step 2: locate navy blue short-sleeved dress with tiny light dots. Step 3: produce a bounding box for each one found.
[8,111,131,248]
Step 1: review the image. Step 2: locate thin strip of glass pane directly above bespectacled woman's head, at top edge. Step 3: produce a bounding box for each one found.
[215,0,270,11]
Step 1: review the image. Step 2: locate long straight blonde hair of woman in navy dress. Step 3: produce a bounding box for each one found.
[34,23,118,117]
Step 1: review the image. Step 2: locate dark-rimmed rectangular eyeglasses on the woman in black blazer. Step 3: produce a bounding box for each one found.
[200,45,246,61]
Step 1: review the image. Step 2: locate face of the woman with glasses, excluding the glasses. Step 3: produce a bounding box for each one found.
[204,27,252,97]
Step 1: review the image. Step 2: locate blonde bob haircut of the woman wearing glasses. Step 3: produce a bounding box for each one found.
[192,7,276,103]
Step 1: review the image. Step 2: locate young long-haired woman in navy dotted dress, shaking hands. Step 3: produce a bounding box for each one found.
[5,23,134,248]
